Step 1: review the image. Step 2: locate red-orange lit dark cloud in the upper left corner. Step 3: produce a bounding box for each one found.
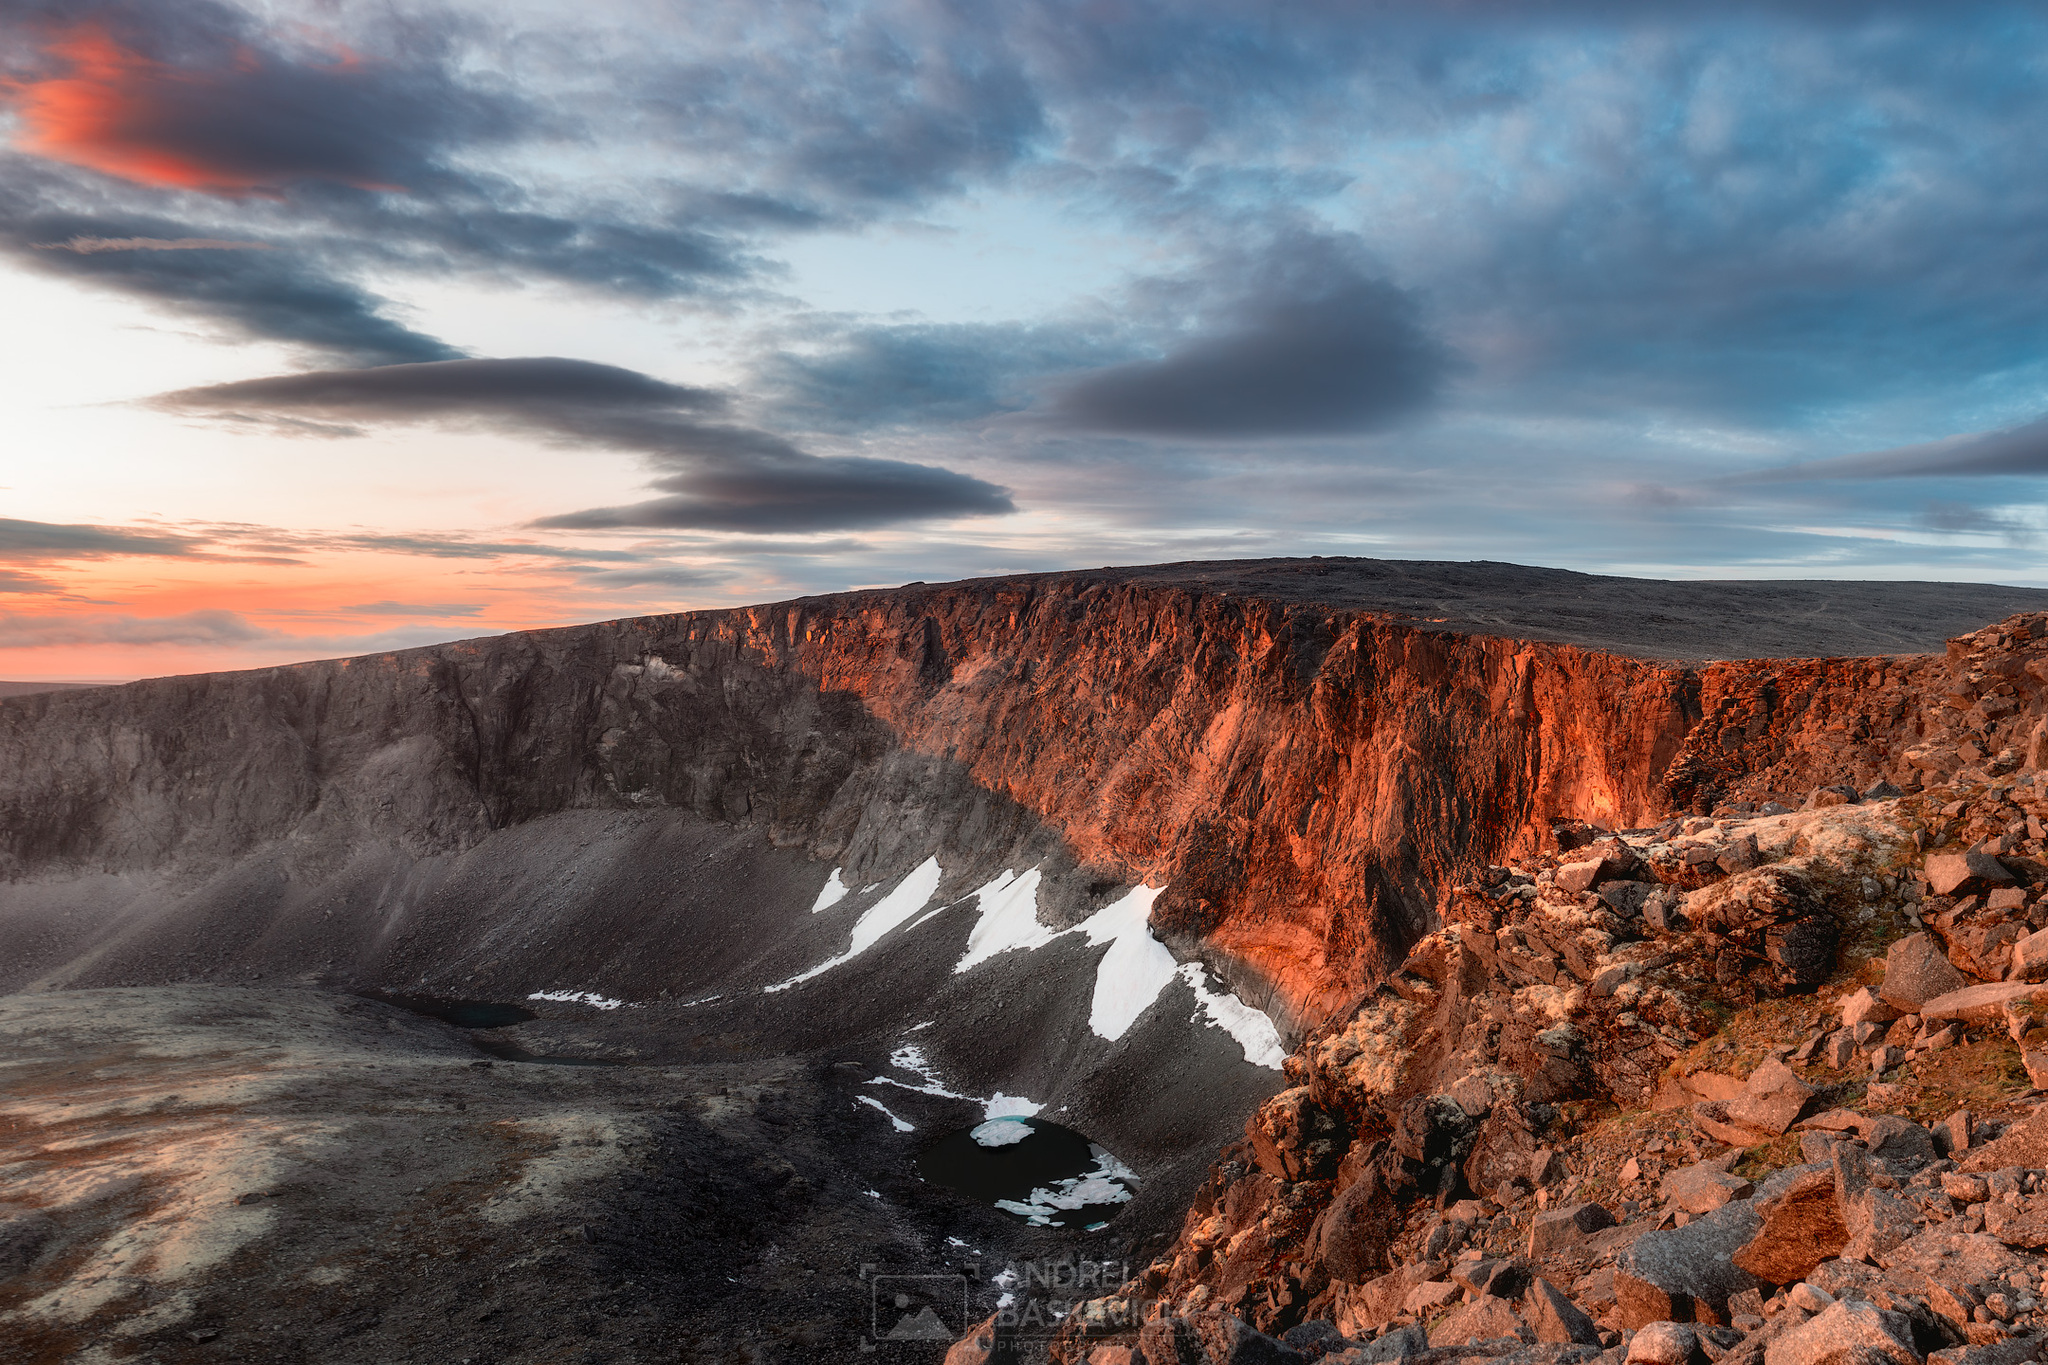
[14,25,399,194]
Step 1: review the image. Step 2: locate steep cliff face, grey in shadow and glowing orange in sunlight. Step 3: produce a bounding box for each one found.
[0,571,2023,1027]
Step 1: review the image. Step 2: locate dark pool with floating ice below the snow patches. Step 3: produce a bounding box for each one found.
[918,1117,1139,1228]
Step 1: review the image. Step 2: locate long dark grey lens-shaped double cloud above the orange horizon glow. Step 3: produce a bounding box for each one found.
[154,356,1016,532]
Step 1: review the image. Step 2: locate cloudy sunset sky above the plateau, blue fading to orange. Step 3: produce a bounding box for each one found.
[0,0,2048,679]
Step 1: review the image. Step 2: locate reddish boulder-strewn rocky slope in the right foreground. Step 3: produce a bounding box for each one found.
[978,620,2048,1365]
